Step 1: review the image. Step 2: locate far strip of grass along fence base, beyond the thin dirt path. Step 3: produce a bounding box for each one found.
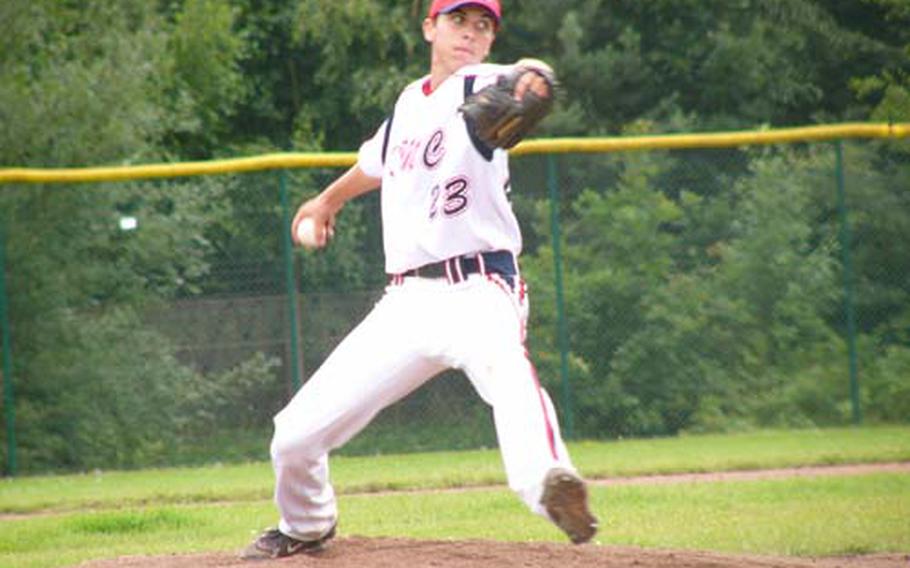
[0,426,910,514]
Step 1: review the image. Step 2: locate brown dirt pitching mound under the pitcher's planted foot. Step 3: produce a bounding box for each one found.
[82,537,910,568]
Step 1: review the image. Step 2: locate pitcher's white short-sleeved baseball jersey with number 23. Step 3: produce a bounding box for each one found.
[358,64,521,274]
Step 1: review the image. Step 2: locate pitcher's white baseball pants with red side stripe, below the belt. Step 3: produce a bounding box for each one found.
[271,274,574,540]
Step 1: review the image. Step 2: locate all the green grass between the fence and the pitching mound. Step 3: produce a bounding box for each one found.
[0,427,910,567]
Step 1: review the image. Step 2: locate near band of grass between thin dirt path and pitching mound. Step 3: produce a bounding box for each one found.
[0,474,910,568]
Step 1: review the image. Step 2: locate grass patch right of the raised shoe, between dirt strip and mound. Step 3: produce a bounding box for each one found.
[598,474,910,555]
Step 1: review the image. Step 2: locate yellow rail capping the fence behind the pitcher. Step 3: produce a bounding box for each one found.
[0,123,910,183]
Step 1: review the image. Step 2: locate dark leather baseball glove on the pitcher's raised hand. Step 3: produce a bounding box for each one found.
[459,65,556,148]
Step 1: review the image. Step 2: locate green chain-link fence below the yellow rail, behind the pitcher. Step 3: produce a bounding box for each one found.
[0,127,910,472]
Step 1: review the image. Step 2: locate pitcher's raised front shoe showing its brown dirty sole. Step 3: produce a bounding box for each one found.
[540,468,597,544]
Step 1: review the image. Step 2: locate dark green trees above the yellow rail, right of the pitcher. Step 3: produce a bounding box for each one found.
[498,0,908,134]
